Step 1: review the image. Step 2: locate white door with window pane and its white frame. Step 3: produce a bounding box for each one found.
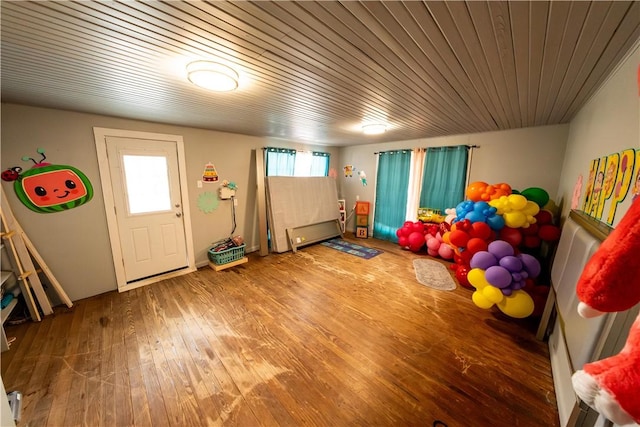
[94,128,195,291]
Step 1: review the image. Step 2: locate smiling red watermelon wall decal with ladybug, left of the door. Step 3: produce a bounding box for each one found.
[2,148,93,213]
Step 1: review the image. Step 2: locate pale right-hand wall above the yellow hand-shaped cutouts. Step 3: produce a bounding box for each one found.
[556,44,640,226]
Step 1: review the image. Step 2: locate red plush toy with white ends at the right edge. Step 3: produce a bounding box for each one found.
[572,198,640,425]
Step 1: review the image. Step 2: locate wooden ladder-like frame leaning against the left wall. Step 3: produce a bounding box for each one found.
[0,190,73,322]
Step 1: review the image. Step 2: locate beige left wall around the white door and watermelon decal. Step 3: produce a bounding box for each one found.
[1,104,338,300]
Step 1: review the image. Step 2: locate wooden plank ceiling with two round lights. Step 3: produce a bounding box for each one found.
[1,1,640,146]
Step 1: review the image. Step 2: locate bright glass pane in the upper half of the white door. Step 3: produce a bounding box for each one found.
[122,155,171,214]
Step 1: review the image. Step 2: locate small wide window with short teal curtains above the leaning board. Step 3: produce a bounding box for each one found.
[265,147,330,176]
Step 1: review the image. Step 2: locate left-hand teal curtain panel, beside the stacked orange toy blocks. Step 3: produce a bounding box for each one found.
[373,150,411,243]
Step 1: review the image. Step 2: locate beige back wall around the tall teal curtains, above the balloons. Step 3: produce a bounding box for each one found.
[338,125,569,230]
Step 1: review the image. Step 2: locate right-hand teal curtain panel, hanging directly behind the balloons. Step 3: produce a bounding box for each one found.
[420,145,468,213]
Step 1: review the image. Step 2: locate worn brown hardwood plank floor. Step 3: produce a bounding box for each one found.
[2,239,558,427]
